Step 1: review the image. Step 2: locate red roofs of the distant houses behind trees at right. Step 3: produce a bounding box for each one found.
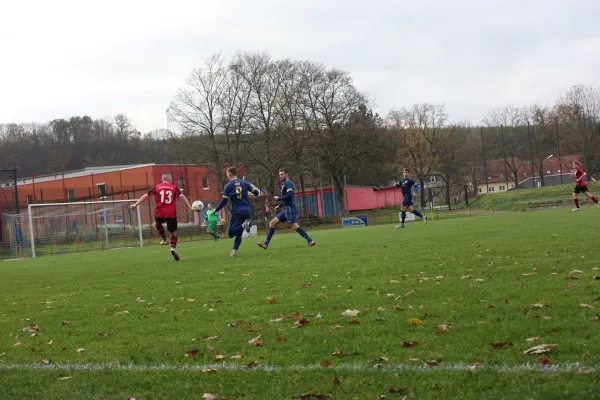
[475,155,579,183]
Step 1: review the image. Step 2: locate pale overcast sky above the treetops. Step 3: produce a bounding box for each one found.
[0,0,600,132]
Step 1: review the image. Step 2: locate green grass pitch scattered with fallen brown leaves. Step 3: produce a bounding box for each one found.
[0,208,600,400]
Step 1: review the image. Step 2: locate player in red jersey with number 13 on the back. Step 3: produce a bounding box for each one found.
[131,173,194,261]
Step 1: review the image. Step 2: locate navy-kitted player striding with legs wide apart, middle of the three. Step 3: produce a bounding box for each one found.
[257,169,316,250]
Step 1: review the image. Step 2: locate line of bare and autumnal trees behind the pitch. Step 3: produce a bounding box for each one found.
[0,52,600,214]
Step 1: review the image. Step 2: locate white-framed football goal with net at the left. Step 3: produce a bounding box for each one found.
[5,200,143,258]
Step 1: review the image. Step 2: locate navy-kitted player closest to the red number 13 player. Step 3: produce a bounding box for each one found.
[215,167,260,257]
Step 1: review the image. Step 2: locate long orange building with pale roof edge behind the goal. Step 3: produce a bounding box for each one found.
[17,164,232,207]
